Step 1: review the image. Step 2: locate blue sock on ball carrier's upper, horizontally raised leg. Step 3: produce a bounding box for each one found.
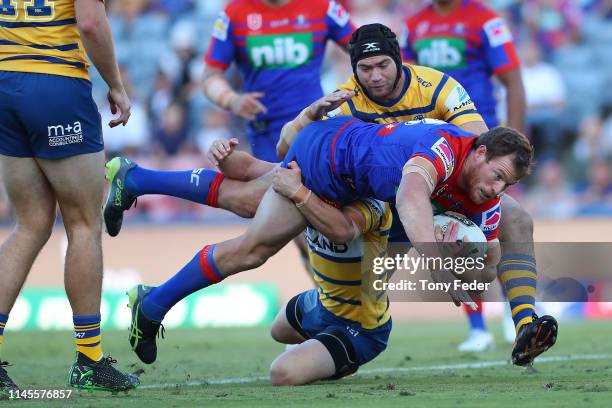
[125,166,223,207]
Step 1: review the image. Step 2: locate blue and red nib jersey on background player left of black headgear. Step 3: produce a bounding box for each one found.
[205,0,354,121]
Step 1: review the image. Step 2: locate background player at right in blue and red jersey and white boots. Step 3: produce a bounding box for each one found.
[402,0,535,351]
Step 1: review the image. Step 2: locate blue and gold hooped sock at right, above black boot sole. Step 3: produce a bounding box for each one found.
[498,254,538,331]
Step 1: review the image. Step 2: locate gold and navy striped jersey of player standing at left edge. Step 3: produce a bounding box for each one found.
[0,0,89,79]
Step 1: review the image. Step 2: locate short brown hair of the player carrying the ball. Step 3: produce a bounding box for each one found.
[472,126,534,180]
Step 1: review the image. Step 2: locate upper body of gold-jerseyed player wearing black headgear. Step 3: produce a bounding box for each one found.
[277,24,487,158]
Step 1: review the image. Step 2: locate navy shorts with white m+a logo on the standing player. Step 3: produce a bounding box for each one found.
[0,71,104,159]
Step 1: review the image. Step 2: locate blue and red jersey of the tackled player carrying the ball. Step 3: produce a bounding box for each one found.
[284,116,501,240]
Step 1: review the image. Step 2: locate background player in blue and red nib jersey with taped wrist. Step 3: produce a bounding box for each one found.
[204,0,354,162]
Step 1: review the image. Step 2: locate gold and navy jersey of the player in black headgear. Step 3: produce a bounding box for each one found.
[328,64,482,126]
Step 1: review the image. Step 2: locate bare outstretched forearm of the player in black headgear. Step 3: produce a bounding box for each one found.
[276,90,355,159]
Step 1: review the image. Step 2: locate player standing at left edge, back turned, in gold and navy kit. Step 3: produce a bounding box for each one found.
[0,0,139,398]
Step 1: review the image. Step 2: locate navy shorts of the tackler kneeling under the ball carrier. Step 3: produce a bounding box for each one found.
[286,289,392,376]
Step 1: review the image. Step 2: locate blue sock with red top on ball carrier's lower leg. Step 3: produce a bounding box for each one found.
[142,245,223,321]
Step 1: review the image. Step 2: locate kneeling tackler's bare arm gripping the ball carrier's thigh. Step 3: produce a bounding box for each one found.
[272,162,366,243]
